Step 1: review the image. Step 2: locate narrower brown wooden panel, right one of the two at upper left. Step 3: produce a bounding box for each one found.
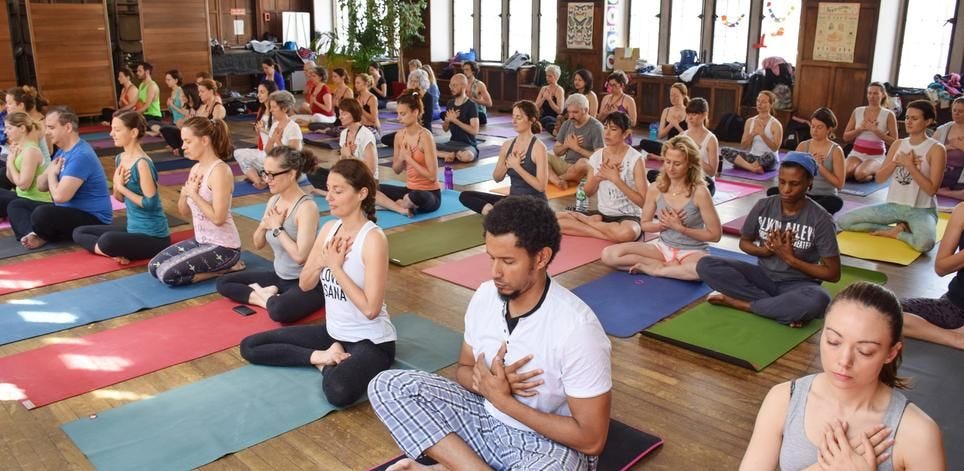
[141,0,211,108]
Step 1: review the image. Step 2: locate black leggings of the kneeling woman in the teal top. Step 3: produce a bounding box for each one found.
[74,224,171,260]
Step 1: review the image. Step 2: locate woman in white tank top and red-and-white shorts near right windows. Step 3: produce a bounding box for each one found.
[844,82,897,182]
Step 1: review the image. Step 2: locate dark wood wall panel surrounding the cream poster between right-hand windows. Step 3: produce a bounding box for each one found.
[793,0,879,136]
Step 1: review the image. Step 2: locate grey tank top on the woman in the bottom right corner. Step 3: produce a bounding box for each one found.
[780,374,907,471]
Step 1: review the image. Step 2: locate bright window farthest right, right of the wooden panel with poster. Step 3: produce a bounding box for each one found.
[897,0,957,88]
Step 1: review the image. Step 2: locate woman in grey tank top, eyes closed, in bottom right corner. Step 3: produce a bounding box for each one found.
[740,281,946,471]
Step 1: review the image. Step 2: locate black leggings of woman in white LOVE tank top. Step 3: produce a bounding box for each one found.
[241,324,395,407]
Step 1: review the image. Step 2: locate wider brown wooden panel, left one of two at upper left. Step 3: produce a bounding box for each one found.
[27,1,117,115]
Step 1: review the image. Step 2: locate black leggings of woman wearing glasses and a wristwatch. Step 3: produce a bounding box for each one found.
[217,271,325,324]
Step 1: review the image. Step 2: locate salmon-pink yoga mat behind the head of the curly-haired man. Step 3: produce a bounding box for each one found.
[422,235,613,290]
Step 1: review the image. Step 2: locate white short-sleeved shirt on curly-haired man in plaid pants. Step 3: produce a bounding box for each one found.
[465,280,612,431]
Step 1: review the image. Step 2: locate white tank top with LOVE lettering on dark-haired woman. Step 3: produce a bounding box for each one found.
[321,220,397,344]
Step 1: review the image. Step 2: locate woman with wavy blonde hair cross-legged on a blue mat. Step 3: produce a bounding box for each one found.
[602,136,723,280]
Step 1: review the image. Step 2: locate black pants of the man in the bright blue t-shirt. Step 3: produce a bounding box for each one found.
[7,198,104,242]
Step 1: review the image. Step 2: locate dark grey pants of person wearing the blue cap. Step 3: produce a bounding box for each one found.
[696,257,830,324]
